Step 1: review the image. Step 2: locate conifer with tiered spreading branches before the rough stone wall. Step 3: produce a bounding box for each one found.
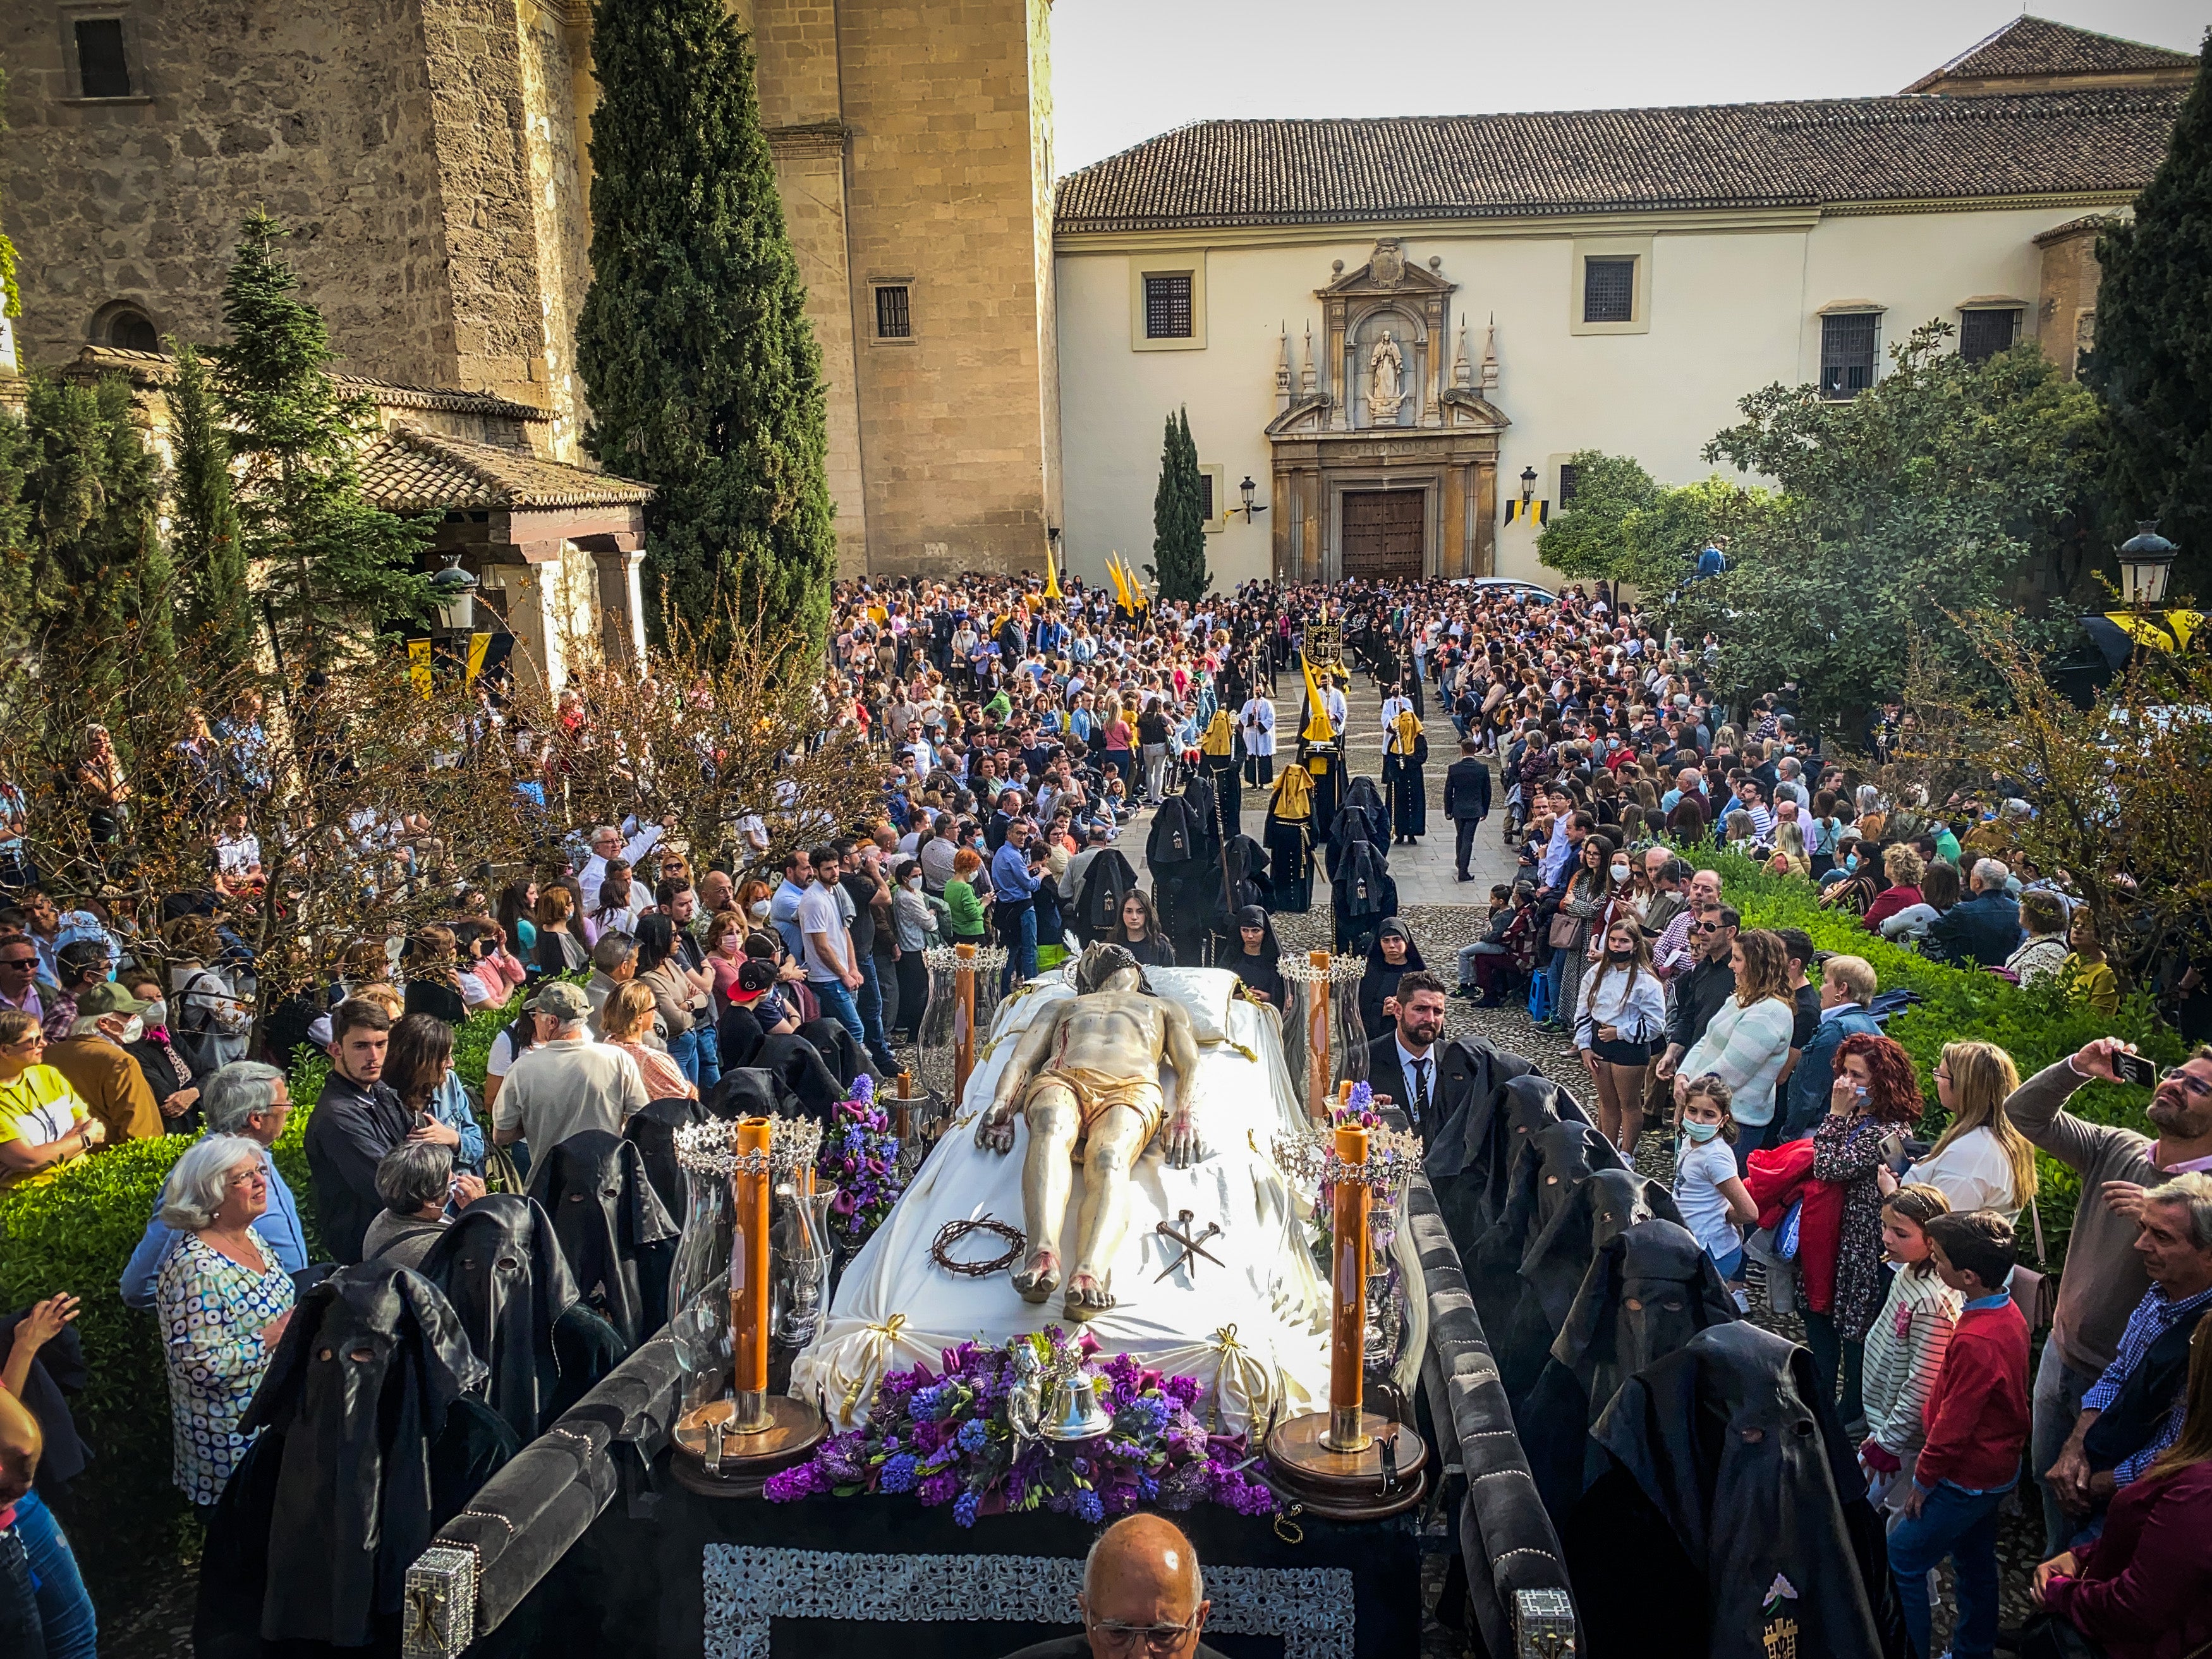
[208,208,429,671]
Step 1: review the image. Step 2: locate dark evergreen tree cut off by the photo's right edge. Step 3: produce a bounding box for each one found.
[2082,35,2212,597]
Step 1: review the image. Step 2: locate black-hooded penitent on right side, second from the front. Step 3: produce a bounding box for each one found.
[1516,1217,1737,1524]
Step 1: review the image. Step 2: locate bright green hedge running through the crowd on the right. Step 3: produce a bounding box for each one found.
[1699,854,2188,1268]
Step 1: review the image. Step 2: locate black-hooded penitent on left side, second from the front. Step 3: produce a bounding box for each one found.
[423,1193,580,1442]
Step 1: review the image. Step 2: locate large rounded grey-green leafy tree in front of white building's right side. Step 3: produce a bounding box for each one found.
[1672,323,2104,728]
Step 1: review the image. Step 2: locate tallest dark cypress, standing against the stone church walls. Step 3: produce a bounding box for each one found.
[575,0,836,641]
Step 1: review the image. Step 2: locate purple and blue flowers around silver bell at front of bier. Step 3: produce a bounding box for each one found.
[768,1325,1277,1526]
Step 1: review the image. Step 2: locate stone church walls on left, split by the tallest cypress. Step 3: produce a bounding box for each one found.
[0,0,1060,573]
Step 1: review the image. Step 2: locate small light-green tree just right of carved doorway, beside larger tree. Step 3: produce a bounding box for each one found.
[1535,449,1772,600]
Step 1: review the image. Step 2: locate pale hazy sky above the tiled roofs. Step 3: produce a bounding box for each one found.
[1053,0,2212,173]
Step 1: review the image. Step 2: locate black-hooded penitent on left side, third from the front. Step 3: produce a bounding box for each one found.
[531,1128,677,1349]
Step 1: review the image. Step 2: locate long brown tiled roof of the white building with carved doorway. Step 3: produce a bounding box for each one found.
[1055,87,2188,233]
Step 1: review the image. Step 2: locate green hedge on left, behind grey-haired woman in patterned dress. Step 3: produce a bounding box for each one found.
[0,995,511,1597]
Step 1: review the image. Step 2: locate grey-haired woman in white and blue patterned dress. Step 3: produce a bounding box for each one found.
[155,1135,292,1509]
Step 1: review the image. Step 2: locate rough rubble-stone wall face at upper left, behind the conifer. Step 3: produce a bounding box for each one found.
[0,0,456,385]
